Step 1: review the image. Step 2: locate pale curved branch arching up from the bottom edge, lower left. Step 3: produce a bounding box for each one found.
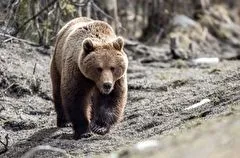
[22,145,73,158]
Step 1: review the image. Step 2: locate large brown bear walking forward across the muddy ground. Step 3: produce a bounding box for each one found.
[51,17,128,139]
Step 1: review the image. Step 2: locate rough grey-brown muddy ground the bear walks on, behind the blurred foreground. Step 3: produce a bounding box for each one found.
[0,41,240,157]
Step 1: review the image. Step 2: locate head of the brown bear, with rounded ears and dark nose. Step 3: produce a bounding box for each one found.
[78,37,128,94]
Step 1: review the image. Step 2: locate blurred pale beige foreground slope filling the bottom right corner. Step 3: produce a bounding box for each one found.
[108,104,240,158]
